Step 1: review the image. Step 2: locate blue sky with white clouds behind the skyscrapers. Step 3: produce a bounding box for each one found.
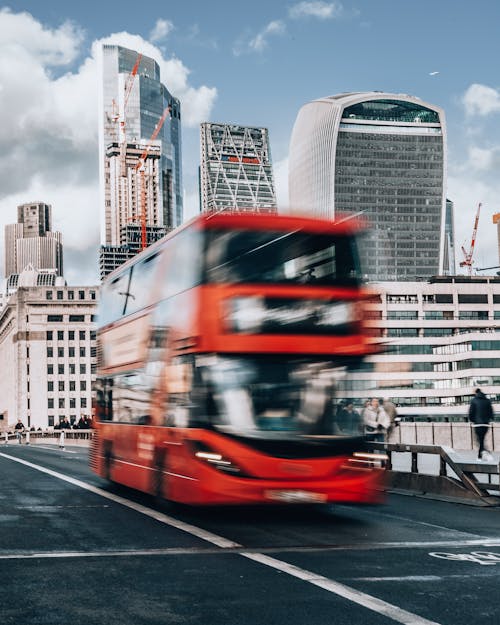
[0,0,500,284]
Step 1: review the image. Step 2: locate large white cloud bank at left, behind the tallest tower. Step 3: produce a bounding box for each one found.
[0,10,217,280]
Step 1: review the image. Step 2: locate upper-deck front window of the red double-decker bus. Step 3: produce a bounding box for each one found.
[205,229,360,286]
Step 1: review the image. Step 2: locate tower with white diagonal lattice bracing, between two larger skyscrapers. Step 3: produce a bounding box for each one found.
[200,122,276,212]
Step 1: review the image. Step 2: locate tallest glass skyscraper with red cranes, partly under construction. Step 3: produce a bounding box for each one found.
[99,45,182,258]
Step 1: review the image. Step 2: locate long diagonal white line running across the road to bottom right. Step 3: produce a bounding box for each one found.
[0,453,466,625]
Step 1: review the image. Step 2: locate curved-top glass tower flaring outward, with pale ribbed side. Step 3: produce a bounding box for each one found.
[289,92,446,281]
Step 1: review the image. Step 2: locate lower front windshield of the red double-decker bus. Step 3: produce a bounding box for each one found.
[193,355,359,438]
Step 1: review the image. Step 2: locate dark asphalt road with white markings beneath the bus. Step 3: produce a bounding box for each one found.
[0,444,500,625]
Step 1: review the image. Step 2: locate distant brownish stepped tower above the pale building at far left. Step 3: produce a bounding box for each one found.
[5,202,63,278]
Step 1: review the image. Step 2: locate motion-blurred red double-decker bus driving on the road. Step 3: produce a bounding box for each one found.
[91,213,382,505]
